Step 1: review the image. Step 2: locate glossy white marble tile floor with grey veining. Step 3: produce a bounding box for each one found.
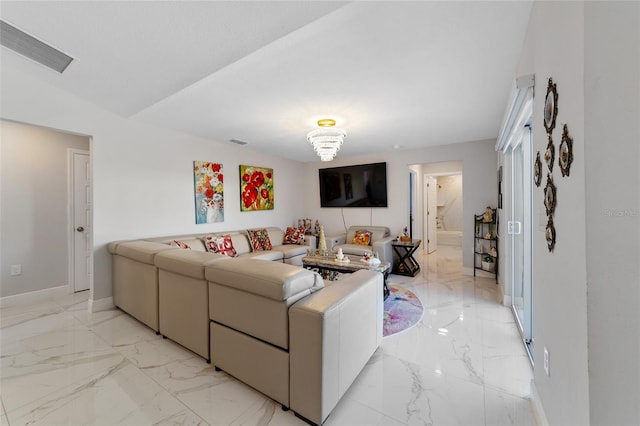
[0,246,534,426]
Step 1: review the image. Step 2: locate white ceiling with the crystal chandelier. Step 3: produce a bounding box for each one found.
[0,1,531,162]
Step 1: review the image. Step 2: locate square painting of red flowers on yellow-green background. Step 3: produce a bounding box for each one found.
[240,165,274,212]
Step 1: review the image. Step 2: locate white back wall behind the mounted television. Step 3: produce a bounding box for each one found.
[302,140,497,274]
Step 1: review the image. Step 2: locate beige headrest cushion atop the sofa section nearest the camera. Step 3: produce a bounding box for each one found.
[205,258,324,300]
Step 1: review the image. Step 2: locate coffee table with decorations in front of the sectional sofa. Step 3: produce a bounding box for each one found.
[302,255,391,299]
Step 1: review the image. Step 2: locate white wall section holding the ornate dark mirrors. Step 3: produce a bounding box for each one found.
[517,1,589,425]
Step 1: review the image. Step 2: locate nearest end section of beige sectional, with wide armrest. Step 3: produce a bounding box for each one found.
[206,261,383,424]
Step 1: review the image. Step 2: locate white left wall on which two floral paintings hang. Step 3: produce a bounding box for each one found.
[1,68,305,300]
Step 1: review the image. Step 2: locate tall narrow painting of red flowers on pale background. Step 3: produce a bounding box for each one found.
[193,161,224,224]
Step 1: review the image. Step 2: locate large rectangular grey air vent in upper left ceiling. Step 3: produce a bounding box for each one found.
[0,20,73,74]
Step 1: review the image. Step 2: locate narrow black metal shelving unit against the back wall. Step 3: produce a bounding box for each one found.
[473,207,498,282]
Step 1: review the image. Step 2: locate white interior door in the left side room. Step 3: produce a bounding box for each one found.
[69,150,92,292]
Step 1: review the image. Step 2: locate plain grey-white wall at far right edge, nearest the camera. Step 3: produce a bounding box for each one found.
[584,2,640,425]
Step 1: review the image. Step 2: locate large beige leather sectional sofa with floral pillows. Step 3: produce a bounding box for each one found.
[109,228,383,424]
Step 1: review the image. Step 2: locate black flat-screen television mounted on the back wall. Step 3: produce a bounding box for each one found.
[318,163,387,207]
